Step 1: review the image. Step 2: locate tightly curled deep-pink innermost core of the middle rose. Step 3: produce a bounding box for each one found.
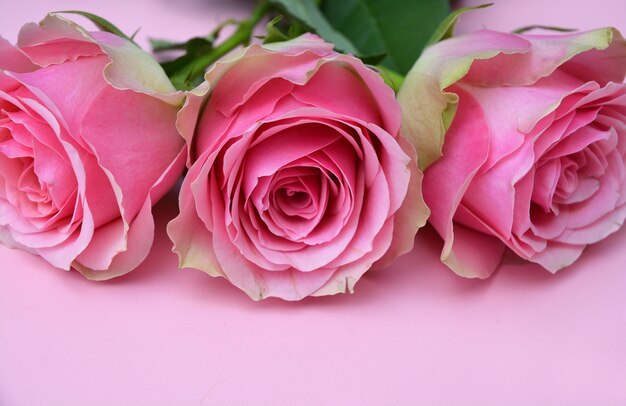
[239,124,356,244]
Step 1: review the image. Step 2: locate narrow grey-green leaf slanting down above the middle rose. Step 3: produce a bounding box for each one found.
[270,0,358,55]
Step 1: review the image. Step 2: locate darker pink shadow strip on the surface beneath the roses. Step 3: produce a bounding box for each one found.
[78,187,626,312]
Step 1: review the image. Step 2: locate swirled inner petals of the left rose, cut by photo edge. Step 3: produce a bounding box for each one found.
[0,76,82,248]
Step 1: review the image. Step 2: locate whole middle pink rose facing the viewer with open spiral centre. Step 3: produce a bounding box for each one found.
[168,35,427,300]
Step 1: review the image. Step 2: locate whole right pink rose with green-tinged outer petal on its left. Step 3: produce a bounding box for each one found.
[399,28,626,278]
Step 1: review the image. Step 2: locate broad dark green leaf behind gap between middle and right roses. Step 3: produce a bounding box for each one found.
[321,0,450,74]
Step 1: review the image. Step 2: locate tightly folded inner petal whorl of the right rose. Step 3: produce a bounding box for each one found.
[523,84,626,249]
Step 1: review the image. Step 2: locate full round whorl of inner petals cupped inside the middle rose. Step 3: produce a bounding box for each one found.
[213,110,400,272]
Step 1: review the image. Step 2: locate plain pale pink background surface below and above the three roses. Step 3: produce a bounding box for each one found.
[0,0,626,406]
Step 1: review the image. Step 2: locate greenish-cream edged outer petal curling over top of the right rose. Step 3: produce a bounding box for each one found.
[398,28,626,169]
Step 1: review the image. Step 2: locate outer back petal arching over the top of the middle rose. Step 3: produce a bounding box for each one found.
[188,34,401,158]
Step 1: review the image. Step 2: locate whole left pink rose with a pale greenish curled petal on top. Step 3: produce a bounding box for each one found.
[0,15,186,280]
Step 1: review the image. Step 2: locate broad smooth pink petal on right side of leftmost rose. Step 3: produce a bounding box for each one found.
[81,87,184,220]
